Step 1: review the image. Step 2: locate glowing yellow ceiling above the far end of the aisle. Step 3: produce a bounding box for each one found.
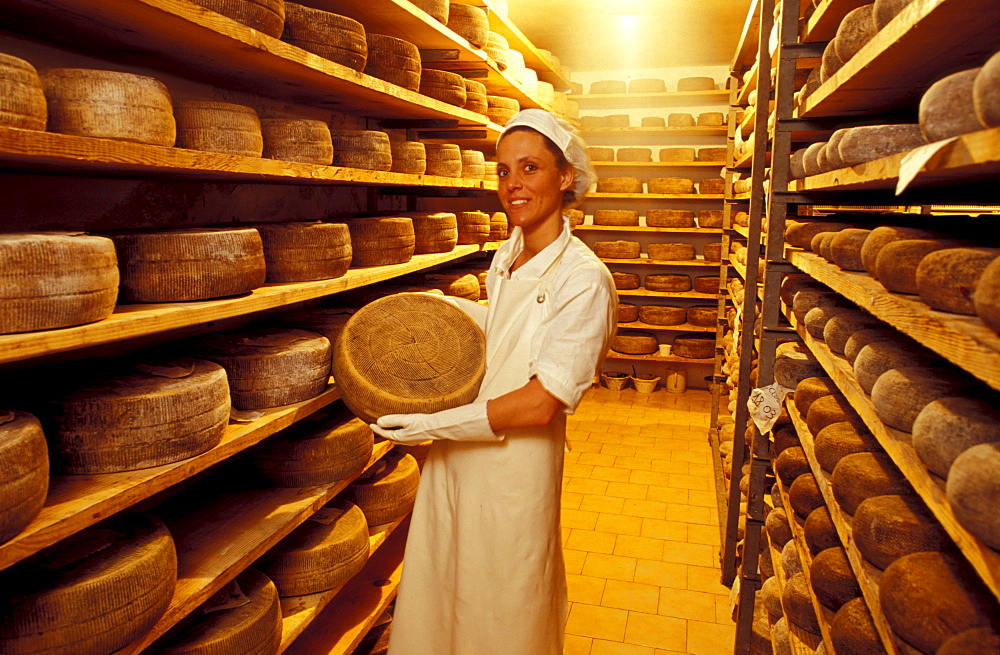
[507,0,750,71]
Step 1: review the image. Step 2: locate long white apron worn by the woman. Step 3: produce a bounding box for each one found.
[389,243,566,655]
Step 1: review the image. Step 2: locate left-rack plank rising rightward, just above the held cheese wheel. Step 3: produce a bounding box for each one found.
[0,245,482,362]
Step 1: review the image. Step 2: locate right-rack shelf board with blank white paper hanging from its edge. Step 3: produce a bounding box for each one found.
[788,127,1000,192]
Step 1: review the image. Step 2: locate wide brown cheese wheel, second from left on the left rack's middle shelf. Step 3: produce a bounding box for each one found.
[111,228,266,302]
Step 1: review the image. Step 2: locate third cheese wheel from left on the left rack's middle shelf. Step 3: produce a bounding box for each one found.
[254,222,351,282]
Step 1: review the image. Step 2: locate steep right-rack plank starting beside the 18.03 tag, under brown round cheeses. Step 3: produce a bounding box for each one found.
[785,398,900,655]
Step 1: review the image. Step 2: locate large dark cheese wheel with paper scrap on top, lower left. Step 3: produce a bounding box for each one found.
[45,357,230,474]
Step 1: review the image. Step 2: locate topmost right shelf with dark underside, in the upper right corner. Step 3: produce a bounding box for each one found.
[798,0,1000,117]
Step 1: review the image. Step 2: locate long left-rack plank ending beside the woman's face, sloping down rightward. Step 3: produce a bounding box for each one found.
[0,127,497,191]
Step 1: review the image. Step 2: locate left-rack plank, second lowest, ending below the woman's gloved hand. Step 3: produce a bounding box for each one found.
[126,441,402,655]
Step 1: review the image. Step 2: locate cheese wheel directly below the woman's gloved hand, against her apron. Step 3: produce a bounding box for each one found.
[344,450,420,527]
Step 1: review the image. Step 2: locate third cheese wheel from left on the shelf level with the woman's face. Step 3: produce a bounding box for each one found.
[174,100,264,157]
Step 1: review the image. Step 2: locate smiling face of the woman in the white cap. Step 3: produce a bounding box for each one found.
[497,130,573,229]
